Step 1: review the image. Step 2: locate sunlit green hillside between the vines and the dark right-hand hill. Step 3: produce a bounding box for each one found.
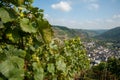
[52,25,106,39]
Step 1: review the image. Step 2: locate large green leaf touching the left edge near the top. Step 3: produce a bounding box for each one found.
[0,8,17,23]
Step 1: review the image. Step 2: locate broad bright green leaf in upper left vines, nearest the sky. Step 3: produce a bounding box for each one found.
[20,18,37,33]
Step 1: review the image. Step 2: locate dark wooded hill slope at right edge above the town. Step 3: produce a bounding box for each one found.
[96,27,120,41]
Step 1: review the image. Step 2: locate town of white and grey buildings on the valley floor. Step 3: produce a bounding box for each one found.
[83,42,120,65]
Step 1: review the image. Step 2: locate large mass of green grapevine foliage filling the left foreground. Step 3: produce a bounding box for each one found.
[0,0,89,80]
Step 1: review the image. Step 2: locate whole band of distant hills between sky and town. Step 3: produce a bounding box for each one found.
[52,26,120,41]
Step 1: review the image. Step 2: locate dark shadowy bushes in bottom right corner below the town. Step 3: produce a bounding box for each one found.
[84,57,120,80]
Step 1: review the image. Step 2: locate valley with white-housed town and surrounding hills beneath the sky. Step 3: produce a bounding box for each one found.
[53,26,120,65]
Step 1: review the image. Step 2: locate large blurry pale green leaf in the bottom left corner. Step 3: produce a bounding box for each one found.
[0,56,24,80]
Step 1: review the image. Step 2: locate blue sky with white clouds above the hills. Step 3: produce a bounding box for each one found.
[33,0,120,29]
